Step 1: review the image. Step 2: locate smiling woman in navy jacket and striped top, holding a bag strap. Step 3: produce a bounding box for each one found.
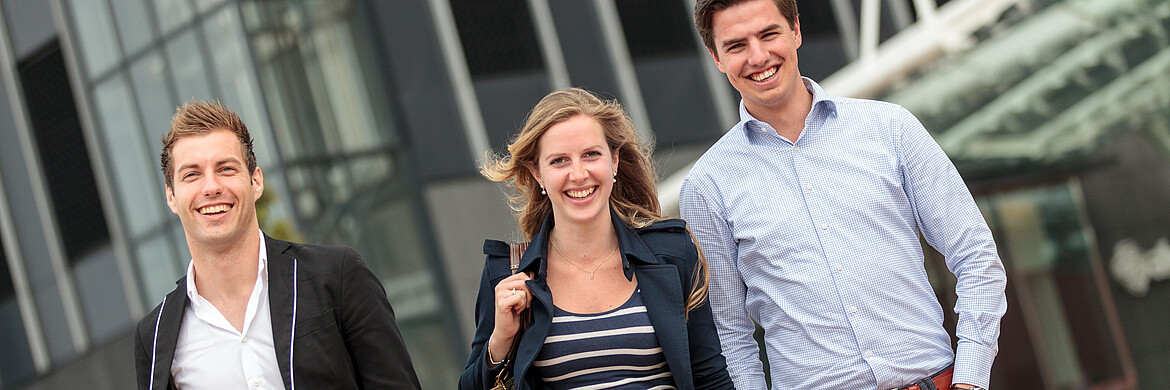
[459,88,731,389]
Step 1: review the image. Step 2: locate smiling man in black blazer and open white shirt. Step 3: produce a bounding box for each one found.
[135,102,420,389]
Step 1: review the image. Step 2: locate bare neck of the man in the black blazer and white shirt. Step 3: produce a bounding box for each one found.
[188,231,260,298]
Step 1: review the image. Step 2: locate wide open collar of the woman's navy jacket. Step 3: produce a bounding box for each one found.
[519,207,662,280]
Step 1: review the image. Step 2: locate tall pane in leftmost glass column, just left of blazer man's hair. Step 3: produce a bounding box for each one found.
[94,74,163,235]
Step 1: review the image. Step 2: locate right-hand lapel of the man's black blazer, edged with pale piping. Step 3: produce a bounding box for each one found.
[264,234,296,389]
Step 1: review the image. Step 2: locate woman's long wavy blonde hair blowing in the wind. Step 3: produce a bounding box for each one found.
[480,88,710,313]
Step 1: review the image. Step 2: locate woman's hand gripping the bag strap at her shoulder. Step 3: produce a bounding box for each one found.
[488,273,532,362]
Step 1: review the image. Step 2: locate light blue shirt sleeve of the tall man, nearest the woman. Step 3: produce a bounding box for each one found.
[679,177,768,389]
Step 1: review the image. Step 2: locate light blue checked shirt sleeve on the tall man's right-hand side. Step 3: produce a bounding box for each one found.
[896,105,1007,388]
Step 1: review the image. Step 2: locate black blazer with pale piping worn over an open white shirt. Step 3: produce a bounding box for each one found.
[135,235,420,389]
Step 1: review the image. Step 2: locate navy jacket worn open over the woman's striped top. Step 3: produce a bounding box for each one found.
[459,211,734,390]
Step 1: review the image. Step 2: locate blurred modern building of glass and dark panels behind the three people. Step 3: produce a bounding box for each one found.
[0,0,1170,389]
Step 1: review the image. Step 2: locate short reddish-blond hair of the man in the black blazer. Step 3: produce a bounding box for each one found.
[159,101,256,189]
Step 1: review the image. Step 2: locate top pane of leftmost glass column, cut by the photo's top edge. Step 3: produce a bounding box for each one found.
[69,0,121,77]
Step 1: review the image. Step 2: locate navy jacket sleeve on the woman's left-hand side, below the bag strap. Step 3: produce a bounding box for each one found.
[459,241,508,390]
